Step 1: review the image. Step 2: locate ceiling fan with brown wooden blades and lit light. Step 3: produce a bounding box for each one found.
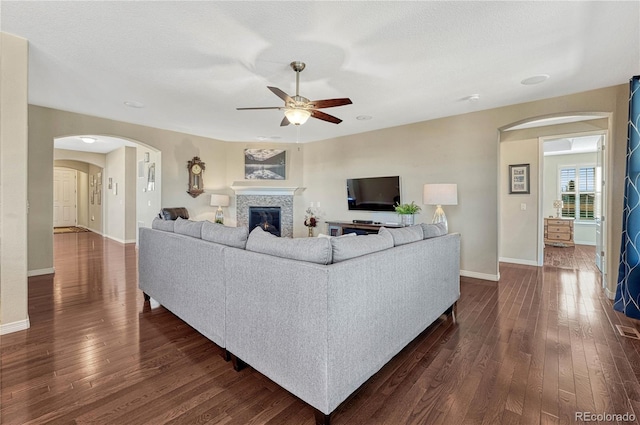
[236,61,351,127]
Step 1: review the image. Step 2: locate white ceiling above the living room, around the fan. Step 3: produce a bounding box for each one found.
[0,0,640,146]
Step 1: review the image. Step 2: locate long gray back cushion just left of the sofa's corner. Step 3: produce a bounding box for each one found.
[247,227,331,264]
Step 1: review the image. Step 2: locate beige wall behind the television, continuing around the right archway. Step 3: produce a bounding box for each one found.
[308,85,628,285]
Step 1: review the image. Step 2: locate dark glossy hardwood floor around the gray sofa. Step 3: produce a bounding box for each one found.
[0,233,640,424]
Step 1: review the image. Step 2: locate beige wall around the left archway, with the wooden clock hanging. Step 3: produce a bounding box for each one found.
[29,105,232,270]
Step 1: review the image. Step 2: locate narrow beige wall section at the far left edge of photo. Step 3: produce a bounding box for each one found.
[0,33,29,334]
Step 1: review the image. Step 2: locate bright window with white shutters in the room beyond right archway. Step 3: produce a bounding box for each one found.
[560,166,596,220]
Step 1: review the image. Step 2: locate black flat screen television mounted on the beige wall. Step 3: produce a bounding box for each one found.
[347,176,400,211]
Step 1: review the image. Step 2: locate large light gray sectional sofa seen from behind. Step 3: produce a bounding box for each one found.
[139,219,460,423]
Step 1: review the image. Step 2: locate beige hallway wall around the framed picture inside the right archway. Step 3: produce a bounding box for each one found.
[498,112,611,296]
